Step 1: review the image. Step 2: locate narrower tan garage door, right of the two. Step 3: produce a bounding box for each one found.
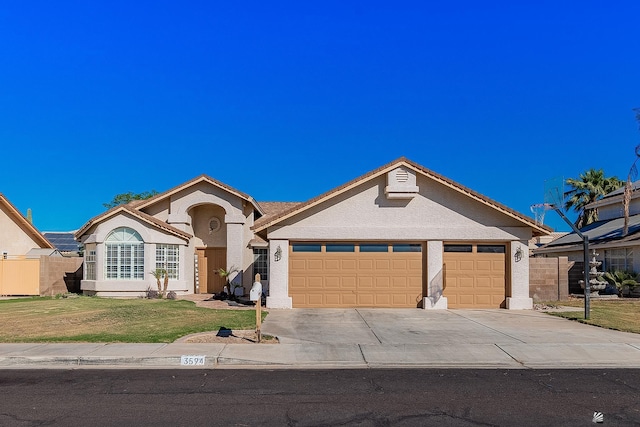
[443,244,506,308]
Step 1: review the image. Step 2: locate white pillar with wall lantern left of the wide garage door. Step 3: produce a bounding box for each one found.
[267,240,293,308]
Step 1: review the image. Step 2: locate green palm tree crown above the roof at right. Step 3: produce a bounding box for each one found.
[564,169,623,228]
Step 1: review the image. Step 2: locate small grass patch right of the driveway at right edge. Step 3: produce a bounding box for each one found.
[548,299,640,334]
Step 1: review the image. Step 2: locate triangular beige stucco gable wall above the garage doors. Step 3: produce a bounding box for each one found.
[268,176,531,241]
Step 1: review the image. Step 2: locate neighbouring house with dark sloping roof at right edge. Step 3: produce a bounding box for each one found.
[534,181,640,272]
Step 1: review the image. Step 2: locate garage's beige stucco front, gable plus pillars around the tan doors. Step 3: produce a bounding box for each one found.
[267,175,532,309]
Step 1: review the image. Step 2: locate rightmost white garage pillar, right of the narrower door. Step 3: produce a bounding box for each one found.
[507,241,533,310]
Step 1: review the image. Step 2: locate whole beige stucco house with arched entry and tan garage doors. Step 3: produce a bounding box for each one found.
[76,158,551,309]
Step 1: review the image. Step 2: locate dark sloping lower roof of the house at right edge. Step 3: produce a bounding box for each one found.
[534,214,640,253]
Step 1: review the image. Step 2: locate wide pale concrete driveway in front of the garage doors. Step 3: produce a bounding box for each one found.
[262,309,640,345]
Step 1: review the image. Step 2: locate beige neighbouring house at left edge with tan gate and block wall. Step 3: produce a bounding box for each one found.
[0,194,82,295]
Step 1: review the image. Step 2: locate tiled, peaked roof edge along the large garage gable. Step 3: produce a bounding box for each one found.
[253,157,552,236]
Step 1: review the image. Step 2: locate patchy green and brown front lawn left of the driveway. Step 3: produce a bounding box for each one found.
[0,297,266,343]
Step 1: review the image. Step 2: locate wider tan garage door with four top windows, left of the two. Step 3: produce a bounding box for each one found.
[289,243,424,308]
